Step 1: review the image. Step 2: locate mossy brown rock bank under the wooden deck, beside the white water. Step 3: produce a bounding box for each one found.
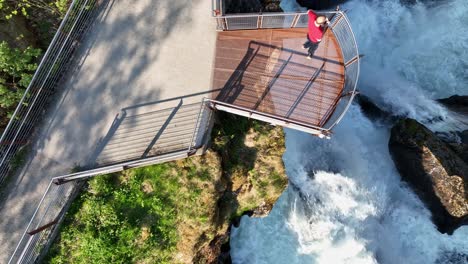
[189,113,288,263]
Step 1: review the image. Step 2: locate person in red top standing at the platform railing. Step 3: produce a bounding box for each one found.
[302,10,329,60]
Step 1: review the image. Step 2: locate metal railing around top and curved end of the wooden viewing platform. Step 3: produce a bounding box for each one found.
[213,9,360,135]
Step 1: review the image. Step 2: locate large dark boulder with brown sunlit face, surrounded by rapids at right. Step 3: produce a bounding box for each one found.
[389,118,468,234]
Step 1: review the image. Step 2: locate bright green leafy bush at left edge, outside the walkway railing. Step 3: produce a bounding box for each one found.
[0,41,41,114]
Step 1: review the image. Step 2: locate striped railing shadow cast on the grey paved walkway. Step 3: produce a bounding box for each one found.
[87,89,220,167]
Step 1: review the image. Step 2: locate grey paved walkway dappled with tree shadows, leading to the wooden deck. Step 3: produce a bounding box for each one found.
[0,0,216,263]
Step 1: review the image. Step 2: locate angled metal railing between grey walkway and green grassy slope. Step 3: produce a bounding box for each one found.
[8,100,213,263]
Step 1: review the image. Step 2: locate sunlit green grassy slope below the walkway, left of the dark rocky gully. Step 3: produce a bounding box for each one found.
[46,154,223,263]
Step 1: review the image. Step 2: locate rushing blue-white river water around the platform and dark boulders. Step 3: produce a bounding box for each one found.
[231,0,468,263]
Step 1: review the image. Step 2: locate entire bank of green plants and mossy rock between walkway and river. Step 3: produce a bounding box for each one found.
[46,113,287,263]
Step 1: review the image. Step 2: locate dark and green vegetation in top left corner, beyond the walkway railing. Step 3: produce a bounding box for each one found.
[0,0,70,131]
